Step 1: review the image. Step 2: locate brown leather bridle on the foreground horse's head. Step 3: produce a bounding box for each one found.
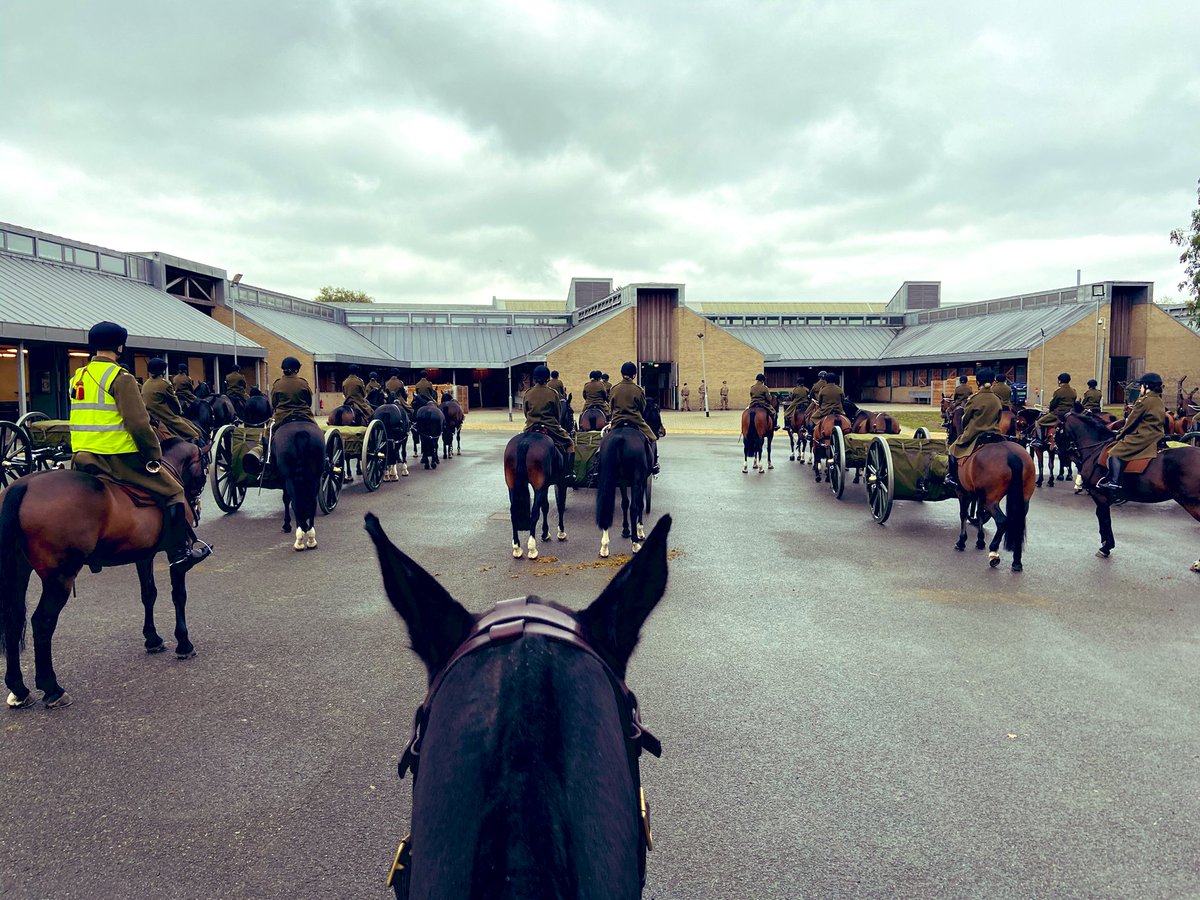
[388,596,662,900]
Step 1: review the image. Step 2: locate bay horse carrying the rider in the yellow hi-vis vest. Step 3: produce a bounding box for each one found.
[0,438,205,709]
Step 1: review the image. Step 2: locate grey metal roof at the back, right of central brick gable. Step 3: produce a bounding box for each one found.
[722,325,896,366]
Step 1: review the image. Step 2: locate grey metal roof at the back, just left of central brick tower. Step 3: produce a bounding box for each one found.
[354,325,565,368]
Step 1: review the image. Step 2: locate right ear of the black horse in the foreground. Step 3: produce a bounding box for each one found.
[577,516,671,678]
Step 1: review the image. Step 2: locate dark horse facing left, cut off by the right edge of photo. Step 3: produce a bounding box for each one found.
[1064,413,1200,572]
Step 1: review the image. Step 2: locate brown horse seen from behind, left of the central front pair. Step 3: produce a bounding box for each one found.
[504,428,566,559]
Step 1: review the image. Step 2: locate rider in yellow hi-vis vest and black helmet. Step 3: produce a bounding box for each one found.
[71,322,212,572]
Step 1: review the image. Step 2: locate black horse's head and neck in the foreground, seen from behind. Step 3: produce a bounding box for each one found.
[366,514,671,900]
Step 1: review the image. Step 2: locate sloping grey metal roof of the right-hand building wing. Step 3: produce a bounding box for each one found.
[880,304,1096,362]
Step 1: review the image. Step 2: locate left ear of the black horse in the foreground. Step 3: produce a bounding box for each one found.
[366,512,474,680]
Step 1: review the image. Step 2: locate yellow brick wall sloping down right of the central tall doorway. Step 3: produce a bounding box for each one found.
[672,306,763,409]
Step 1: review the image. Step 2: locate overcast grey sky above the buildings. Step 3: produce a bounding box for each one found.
[0,0,1200,302]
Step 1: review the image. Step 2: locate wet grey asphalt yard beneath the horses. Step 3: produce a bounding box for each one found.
[0,433,1200,900]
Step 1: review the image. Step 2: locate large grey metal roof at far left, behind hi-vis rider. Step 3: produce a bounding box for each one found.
[0,253,266,358]
